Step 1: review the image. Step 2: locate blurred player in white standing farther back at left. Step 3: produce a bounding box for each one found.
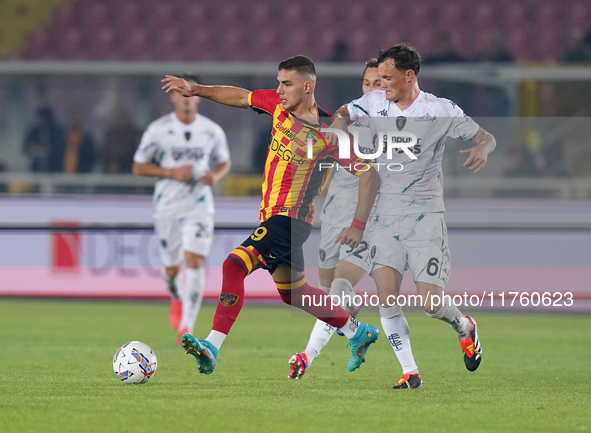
[133,75,230,344]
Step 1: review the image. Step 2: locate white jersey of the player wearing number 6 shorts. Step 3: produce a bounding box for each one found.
[347,90,479,215]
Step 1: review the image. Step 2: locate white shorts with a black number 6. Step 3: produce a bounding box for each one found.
[369,212,451,288]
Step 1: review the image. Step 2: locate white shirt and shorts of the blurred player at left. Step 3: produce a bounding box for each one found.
[133,113,230,267]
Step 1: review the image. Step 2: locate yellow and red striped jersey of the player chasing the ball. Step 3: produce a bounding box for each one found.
[248,90,367,224]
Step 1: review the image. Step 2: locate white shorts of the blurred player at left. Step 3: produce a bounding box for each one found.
[154,213,214,268]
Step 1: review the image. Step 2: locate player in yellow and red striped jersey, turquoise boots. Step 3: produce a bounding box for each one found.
[162,56,379,374]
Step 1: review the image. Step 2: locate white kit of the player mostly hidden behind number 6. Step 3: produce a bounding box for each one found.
[318,124,373,272]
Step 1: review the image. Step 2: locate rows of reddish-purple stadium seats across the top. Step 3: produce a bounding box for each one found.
[13,0,591,62]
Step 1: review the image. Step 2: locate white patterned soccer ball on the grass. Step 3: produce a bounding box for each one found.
[113,341,157,383]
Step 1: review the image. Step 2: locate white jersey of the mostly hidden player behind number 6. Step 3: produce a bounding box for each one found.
[320,119,374,227]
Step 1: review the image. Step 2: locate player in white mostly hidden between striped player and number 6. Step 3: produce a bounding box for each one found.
[287,58,380,379]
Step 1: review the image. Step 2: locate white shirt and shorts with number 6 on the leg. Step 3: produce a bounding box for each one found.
[347,90,479,288]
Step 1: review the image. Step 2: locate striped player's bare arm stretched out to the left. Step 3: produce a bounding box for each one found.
[161,75,250,108]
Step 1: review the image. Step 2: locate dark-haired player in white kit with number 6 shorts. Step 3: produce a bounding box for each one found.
[327,43,496,389]
